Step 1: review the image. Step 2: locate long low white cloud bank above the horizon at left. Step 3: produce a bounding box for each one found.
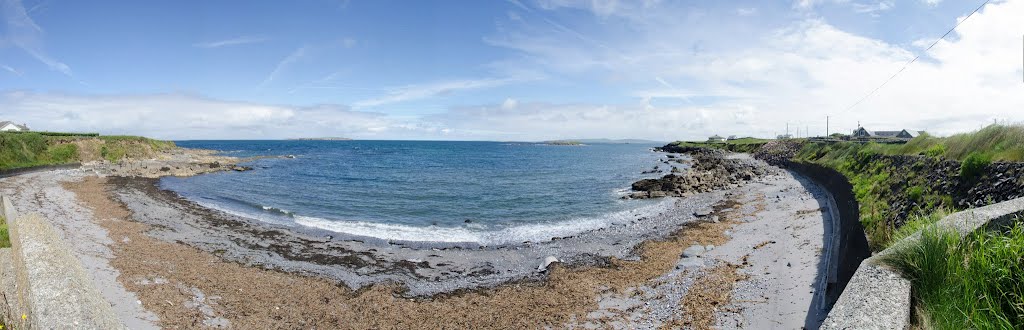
[0,91,432,139]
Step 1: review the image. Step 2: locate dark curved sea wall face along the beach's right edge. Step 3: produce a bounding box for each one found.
[784,162,871,307]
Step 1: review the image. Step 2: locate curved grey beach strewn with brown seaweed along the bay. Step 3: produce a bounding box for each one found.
[0,148,831,329]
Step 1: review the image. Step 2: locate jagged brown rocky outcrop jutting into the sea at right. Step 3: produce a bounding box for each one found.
[627,145,770,199]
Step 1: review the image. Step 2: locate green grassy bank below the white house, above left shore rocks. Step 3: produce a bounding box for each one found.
[0,132,174,170]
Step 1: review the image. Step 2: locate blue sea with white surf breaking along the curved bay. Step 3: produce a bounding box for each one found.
[160,140,679,245]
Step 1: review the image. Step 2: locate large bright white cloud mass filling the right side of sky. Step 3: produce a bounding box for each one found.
[479,0,1024,138]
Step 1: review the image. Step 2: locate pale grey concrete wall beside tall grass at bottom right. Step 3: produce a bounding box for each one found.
[821,193,1024,329]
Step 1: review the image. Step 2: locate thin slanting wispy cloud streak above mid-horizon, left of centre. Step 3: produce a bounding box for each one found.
[352,78,525,109]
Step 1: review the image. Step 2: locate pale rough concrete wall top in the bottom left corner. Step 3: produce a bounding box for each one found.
[0,197,125,329]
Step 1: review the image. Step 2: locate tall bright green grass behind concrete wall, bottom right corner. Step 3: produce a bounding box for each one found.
[885,223,1024,329]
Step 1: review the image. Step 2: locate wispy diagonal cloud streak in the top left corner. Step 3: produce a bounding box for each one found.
[0,0,74,77]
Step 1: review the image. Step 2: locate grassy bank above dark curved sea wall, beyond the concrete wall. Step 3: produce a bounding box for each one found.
[794,125,1024,250]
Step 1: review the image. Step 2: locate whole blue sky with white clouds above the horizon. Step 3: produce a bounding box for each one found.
[0,0,1024,140]
